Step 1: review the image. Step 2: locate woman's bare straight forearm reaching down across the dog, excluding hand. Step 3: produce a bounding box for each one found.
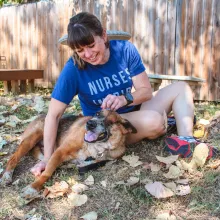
[44,98,67,163]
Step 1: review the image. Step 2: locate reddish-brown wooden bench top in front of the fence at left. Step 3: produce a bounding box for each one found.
[0,69,44,81]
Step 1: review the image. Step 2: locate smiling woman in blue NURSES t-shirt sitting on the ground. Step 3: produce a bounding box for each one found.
[31,12,194,175]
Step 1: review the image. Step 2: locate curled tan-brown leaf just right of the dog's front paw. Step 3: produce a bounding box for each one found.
[43,181,69,198]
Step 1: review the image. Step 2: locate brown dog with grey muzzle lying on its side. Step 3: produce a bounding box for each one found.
[0,110,137,199]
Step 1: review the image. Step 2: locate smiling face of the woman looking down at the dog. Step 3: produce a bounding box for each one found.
[75,32,109,65]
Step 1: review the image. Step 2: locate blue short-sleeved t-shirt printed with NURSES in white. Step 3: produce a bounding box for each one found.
[52,40,145,116]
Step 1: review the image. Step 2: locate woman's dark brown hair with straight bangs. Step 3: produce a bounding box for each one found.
[67,12,109,69]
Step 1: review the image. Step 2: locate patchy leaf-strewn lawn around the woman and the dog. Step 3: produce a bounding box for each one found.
[0,90,220,220]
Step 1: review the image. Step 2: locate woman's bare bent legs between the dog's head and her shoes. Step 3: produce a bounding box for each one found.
[122,82,194,143]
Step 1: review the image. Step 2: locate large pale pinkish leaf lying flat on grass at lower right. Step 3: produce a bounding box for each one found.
[145,182,174,199]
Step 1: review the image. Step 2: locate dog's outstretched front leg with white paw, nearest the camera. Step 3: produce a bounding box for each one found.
[21,147,74,199]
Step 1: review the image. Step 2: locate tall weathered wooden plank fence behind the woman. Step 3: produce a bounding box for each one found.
[0,0,220,101]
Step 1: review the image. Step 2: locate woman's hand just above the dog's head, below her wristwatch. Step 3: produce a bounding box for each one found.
[101,95,127,111]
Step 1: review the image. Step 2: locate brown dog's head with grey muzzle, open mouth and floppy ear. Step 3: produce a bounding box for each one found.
[84,110,137,143]
